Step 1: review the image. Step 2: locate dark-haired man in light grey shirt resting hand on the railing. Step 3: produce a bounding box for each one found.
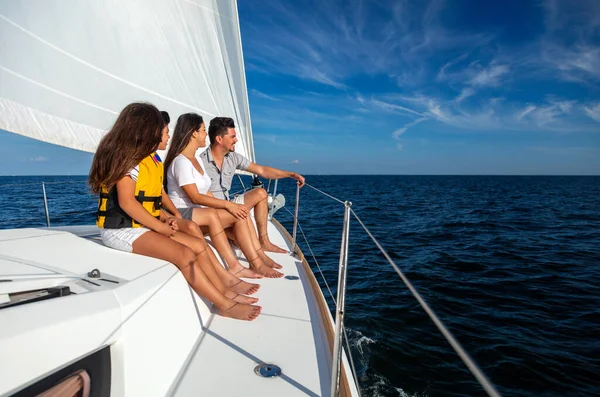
[200,117,304,253]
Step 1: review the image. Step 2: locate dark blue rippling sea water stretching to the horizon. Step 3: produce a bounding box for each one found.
[0,176,600,397]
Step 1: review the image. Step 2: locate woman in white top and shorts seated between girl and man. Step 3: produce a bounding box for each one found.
[165,113,283,278]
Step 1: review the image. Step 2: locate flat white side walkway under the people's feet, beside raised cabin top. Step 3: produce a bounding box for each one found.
[175,221,330,397]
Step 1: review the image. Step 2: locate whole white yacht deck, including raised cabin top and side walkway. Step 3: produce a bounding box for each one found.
[0,220,356,396]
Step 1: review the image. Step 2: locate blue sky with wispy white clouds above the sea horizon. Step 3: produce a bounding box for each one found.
[0,0,600,175]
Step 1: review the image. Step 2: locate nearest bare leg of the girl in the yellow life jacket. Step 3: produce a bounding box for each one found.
[133,231,261,320]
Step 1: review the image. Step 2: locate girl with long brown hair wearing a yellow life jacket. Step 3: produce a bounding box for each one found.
[89,103,261,320]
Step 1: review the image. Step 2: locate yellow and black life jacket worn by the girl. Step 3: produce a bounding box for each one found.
[96,152,164,229]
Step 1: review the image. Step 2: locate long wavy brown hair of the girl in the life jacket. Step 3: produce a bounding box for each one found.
[88,103,165,194]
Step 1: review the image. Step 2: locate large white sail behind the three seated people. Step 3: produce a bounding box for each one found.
[0,0,255,161]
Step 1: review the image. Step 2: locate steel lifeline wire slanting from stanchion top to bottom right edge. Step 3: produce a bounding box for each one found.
[350,209,500,397]
